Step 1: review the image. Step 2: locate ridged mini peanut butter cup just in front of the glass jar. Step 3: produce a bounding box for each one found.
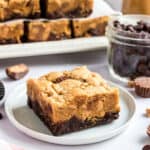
[131,77,150,98]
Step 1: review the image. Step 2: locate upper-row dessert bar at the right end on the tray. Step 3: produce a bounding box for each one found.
[43,0,94,19]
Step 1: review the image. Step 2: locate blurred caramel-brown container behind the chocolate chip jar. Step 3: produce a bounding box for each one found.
[122,0,150,15]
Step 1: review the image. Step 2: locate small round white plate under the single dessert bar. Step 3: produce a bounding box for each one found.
[5,82,136,145]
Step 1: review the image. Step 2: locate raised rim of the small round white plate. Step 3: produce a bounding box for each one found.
[4,80,136,145]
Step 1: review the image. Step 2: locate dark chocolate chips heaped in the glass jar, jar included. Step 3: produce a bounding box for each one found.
[106,15,150,81]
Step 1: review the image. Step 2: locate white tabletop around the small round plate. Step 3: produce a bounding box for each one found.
[0,50,150,150]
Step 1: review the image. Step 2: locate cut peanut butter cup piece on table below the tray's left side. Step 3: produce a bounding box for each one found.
[6,64,29,80]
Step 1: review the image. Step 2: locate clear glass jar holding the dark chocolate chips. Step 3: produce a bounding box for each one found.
[106,15,150,81]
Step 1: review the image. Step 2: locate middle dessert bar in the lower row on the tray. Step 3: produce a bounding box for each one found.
[27,19,71,42]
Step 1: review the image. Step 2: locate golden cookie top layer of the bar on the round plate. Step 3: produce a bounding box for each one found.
[27,67,120,123]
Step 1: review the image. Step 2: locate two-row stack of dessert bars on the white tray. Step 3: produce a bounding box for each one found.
[0,0,108,44]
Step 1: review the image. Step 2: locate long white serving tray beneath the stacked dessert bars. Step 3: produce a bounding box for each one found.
[0,0,120,59]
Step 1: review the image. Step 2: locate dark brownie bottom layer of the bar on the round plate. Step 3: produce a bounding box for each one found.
[28,98,119,136]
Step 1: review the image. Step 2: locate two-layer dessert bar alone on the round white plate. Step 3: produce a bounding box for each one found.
[27,66,120,136]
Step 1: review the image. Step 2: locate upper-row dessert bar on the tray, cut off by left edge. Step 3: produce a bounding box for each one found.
[0,0,41,21]
